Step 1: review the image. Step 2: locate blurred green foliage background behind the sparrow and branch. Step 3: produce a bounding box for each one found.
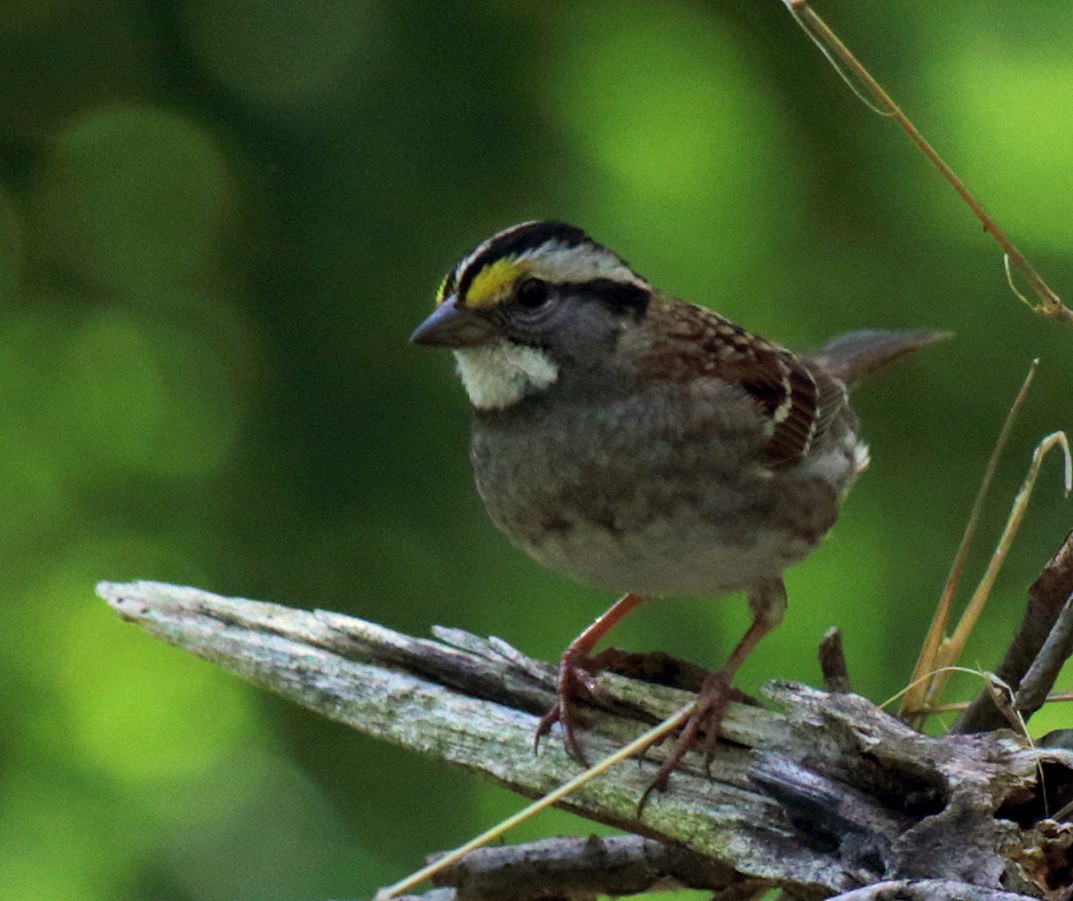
[0,0,1073,901]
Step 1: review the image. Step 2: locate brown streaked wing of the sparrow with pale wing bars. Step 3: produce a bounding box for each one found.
[641,298,847,466]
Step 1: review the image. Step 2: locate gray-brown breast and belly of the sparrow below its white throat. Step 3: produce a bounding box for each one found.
[471,394,851,596]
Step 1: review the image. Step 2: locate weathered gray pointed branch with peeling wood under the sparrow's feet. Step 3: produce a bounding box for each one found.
[99,582,1073,900]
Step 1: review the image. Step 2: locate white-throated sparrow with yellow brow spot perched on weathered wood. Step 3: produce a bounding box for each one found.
[412,222,938,787]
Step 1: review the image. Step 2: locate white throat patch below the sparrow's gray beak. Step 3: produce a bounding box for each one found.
[455,340,559,410]
